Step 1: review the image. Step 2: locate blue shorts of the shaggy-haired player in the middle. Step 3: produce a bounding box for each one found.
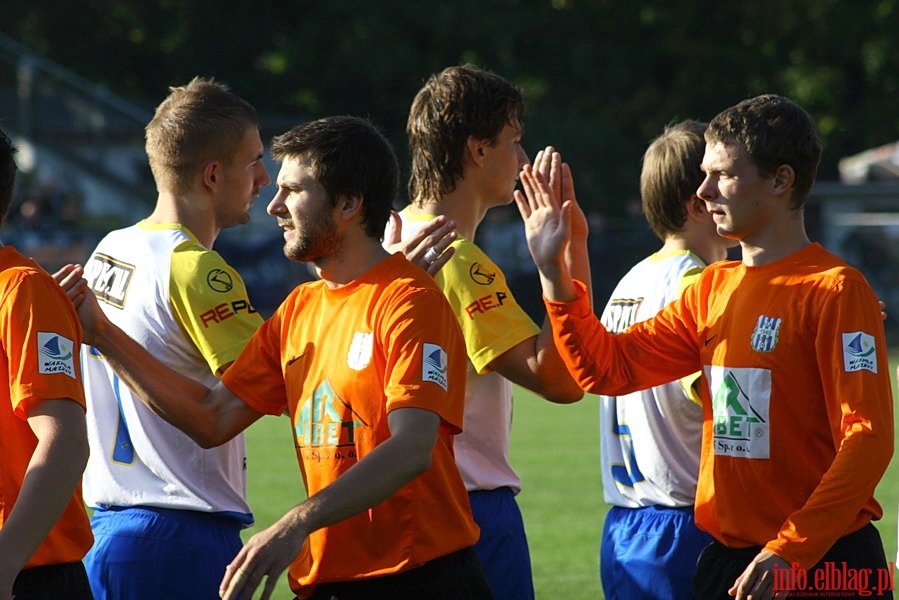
[468,487,534,600]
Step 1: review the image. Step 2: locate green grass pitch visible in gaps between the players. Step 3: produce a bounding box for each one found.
[247,364,899,600]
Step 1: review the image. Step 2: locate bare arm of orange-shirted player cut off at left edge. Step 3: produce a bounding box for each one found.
[0,398,88,598]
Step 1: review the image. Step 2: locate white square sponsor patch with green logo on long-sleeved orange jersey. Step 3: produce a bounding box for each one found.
[706,366,771,458]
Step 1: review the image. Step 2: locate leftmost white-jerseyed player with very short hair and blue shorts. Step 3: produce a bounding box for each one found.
[67,78,271,600]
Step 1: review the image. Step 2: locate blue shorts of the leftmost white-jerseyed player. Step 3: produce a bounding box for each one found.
[84,507,242,600]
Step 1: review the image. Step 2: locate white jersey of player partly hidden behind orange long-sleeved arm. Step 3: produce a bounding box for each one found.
[600,251,705,508]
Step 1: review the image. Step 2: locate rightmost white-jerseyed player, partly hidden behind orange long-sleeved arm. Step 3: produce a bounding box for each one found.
[600,121,734,600]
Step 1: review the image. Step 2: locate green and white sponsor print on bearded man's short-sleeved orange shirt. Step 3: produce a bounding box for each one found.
[294,380,368,450]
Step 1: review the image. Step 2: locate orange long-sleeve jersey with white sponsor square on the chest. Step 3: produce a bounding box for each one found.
[546,244,893,568]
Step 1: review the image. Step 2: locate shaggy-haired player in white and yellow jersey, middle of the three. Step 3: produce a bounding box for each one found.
[385,65,587,600]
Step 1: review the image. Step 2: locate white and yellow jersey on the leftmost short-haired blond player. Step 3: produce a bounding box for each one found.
[81,221,262,524]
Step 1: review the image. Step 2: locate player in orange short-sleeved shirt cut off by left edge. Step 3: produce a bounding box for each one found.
[0,125,92,600]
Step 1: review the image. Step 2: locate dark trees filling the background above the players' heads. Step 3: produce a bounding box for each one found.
[0,0,899,217]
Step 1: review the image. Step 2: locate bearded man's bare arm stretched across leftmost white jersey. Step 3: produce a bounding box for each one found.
[53,265,262,448]
